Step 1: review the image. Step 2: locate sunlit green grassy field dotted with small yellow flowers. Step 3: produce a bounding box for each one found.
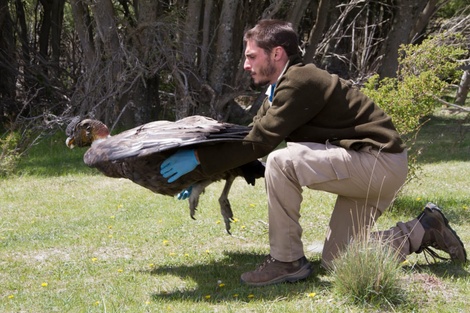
[0,109,470,312]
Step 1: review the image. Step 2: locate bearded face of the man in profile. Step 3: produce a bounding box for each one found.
[243,40,277,86]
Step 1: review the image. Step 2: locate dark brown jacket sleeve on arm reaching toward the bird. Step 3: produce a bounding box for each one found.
[198,64,328,175]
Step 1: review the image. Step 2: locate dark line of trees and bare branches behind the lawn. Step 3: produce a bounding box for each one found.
[0,0,470,134]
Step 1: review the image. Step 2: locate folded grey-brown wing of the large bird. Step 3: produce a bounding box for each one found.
[84,115,250,166]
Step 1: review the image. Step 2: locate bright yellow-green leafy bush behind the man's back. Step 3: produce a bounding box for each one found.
[362,36,465,137]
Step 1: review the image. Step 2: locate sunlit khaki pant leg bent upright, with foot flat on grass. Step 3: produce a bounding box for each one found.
[265,143,362,262]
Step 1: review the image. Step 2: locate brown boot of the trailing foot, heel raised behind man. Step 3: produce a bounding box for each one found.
[416,203,467,263]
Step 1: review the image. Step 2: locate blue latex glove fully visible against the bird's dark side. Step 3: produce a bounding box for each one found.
[160,149,199,183]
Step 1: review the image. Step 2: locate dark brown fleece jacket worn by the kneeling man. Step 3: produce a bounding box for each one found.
[198,57,405,174]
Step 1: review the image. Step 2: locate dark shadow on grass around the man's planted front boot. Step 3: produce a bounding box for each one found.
[143,252,330,303]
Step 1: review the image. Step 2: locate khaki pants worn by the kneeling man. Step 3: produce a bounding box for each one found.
[265,143,424,267]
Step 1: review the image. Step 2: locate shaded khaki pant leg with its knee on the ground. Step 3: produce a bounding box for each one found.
[316,144,412,268]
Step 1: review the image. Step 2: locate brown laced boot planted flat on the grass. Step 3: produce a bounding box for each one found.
[241,255,313,286]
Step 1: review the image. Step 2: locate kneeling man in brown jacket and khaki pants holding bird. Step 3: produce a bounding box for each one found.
[161,20,466,286]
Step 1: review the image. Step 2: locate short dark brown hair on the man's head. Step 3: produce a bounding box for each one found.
[243,19,299,56]
